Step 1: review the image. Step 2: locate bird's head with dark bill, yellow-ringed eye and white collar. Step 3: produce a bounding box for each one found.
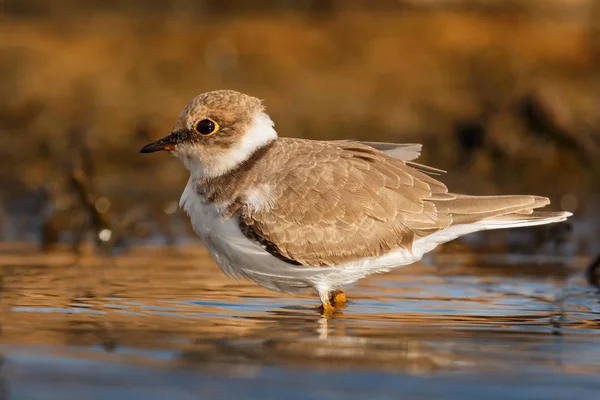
[140,90,277,178]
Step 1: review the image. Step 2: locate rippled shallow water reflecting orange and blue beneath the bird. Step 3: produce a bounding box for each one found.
[0,244,600,399]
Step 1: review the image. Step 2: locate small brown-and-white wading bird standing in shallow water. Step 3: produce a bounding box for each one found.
[140,90,571,314]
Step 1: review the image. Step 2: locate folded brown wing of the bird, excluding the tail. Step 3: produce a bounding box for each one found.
[241,139,455,265]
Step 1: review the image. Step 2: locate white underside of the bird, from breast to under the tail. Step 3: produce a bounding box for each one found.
[180,180,564,298]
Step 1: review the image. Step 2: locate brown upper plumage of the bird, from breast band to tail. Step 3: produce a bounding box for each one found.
[198,138,564,267]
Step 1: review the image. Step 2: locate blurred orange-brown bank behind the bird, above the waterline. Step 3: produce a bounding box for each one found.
[0,0,600,253]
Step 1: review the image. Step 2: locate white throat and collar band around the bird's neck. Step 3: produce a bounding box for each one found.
[176,112,277,179]
